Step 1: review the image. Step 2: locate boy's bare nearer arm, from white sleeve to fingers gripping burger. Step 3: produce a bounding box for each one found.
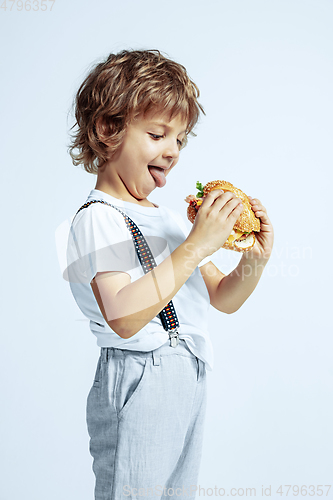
[91,190,242,338]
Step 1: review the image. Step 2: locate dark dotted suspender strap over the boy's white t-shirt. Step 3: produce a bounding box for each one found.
[73,200,179,347]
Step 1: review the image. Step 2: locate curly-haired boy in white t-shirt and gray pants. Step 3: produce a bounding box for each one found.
[68,50,273,500]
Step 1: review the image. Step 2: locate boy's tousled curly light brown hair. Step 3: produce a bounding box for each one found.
[68,50,205,174]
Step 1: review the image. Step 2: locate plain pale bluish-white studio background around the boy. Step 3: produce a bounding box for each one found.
[0,0,333,500]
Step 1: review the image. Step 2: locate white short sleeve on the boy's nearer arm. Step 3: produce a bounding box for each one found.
[64,203,141,283]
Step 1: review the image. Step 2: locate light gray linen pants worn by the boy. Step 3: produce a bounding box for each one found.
[87,340,207,500]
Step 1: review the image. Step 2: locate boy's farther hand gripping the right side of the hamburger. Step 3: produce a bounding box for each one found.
[243,196,274,260]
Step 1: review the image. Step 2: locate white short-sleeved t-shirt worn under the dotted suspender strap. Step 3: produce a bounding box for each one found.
[66,189,213,370]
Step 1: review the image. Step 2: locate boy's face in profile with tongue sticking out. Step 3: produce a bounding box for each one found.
[102,112,187,201]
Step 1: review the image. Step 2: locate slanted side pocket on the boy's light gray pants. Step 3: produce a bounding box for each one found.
[116,354,149,418]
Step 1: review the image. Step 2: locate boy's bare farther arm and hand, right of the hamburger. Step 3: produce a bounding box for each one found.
[200,197,274,314]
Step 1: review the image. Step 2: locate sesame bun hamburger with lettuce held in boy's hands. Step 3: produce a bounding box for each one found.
[185,181,260,252]
